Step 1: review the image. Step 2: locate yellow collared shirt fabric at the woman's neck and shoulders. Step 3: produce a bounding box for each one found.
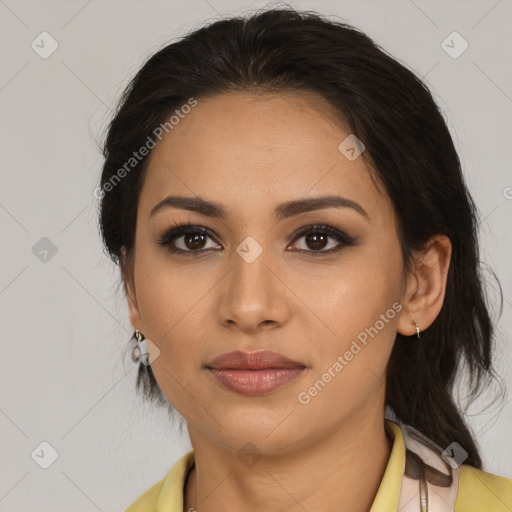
[125,421,512,512]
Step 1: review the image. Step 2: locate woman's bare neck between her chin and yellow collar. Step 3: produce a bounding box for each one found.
[184,411,391,512]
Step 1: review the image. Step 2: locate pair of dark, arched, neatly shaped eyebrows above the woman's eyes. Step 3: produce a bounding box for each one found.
[149,196,370,221]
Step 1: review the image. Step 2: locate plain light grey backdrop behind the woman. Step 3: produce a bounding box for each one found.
[0,0,512,512]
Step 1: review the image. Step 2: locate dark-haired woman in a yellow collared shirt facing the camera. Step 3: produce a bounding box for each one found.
[100,9,512,512]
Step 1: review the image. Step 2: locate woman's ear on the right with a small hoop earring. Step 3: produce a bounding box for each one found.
[397,235,452,336]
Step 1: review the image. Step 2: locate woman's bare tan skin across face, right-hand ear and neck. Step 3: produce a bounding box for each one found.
[123,92,451,512]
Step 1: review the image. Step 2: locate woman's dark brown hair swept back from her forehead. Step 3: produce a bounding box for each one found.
[100,9,501,468]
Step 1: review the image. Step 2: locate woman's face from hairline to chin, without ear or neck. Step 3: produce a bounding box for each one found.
[129,93,403,453]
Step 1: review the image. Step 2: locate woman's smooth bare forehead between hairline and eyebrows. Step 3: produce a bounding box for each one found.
[140,92,390,222]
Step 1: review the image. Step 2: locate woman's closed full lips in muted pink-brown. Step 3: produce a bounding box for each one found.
[206,351,306,396]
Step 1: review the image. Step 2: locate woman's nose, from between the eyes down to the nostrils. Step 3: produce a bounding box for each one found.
[217,246,291,333]
